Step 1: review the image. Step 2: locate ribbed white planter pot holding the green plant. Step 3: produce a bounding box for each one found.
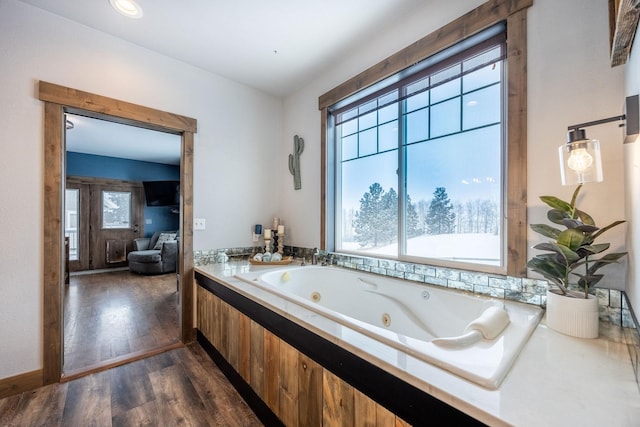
[547,290,599,338]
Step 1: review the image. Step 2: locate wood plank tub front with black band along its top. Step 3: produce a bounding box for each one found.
[196,271,484,426]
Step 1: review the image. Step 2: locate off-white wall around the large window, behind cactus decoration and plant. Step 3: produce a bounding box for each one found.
[282,0,625,289]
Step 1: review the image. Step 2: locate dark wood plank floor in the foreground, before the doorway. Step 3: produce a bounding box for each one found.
[0,343,262,427]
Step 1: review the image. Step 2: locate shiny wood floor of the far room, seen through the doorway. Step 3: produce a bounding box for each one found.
[63,270,179,375]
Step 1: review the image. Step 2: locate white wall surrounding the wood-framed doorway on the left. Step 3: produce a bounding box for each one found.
[0,0,283,378]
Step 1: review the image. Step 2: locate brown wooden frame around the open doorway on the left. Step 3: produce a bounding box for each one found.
[38,81,197,385]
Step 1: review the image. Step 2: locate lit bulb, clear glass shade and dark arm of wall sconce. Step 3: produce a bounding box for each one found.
[558,114,626,185]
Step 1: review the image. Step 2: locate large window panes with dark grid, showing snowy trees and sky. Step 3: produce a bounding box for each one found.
[327,27,507,268]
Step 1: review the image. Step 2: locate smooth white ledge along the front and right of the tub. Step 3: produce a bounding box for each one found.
[196,261,640,426]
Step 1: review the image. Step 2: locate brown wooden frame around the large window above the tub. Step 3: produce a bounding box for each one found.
[319,0,532,277]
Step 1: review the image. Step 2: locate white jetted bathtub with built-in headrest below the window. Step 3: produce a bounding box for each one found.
[236,266,543,389]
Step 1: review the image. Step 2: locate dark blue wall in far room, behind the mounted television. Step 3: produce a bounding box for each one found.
[67,151,180,236]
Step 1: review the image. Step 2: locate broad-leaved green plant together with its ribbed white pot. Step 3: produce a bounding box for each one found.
[527,184,626,338]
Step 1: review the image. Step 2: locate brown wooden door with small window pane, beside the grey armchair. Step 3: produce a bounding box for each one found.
[90,182,144,270]
